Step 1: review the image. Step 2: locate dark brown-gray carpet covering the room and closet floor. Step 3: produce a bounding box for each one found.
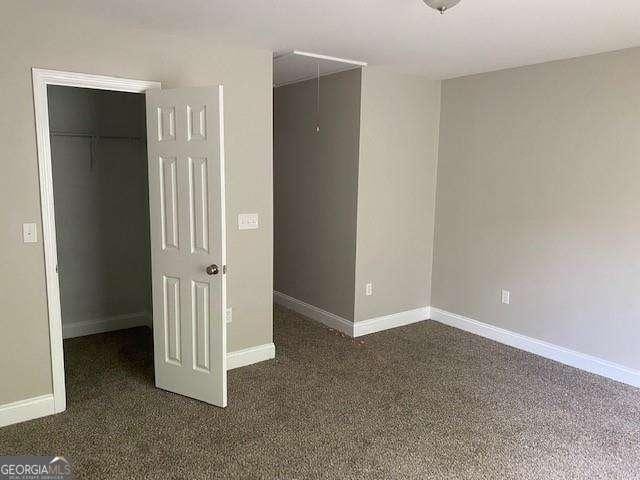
[0,309,640,480]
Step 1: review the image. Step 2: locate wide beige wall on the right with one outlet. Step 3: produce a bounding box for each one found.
[431,49,640,369]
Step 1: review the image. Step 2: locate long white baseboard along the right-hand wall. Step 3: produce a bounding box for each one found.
[431,307,640,387]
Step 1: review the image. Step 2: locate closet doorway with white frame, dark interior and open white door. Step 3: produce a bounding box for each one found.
[33,68,227,415]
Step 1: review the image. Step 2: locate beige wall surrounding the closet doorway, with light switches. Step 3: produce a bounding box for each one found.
[0,2,273,404]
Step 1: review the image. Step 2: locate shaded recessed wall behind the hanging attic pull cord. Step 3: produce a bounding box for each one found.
[273,69,361,320]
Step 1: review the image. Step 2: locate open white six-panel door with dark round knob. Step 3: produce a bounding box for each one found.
[146,86,227,407]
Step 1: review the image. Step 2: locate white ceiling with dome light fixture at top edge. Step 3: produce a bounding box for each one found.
[39,0,640,78]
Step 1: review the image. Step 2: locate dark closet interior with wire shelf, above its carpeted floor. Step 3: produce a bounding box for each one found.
[48,86,152,338]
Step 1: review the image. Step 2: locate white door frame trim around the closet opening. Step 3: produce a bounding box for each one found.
[31,68,161,413]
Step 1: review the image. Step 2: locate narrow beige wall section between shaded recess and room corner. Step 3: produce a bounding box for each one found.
[355,67,440,321]
